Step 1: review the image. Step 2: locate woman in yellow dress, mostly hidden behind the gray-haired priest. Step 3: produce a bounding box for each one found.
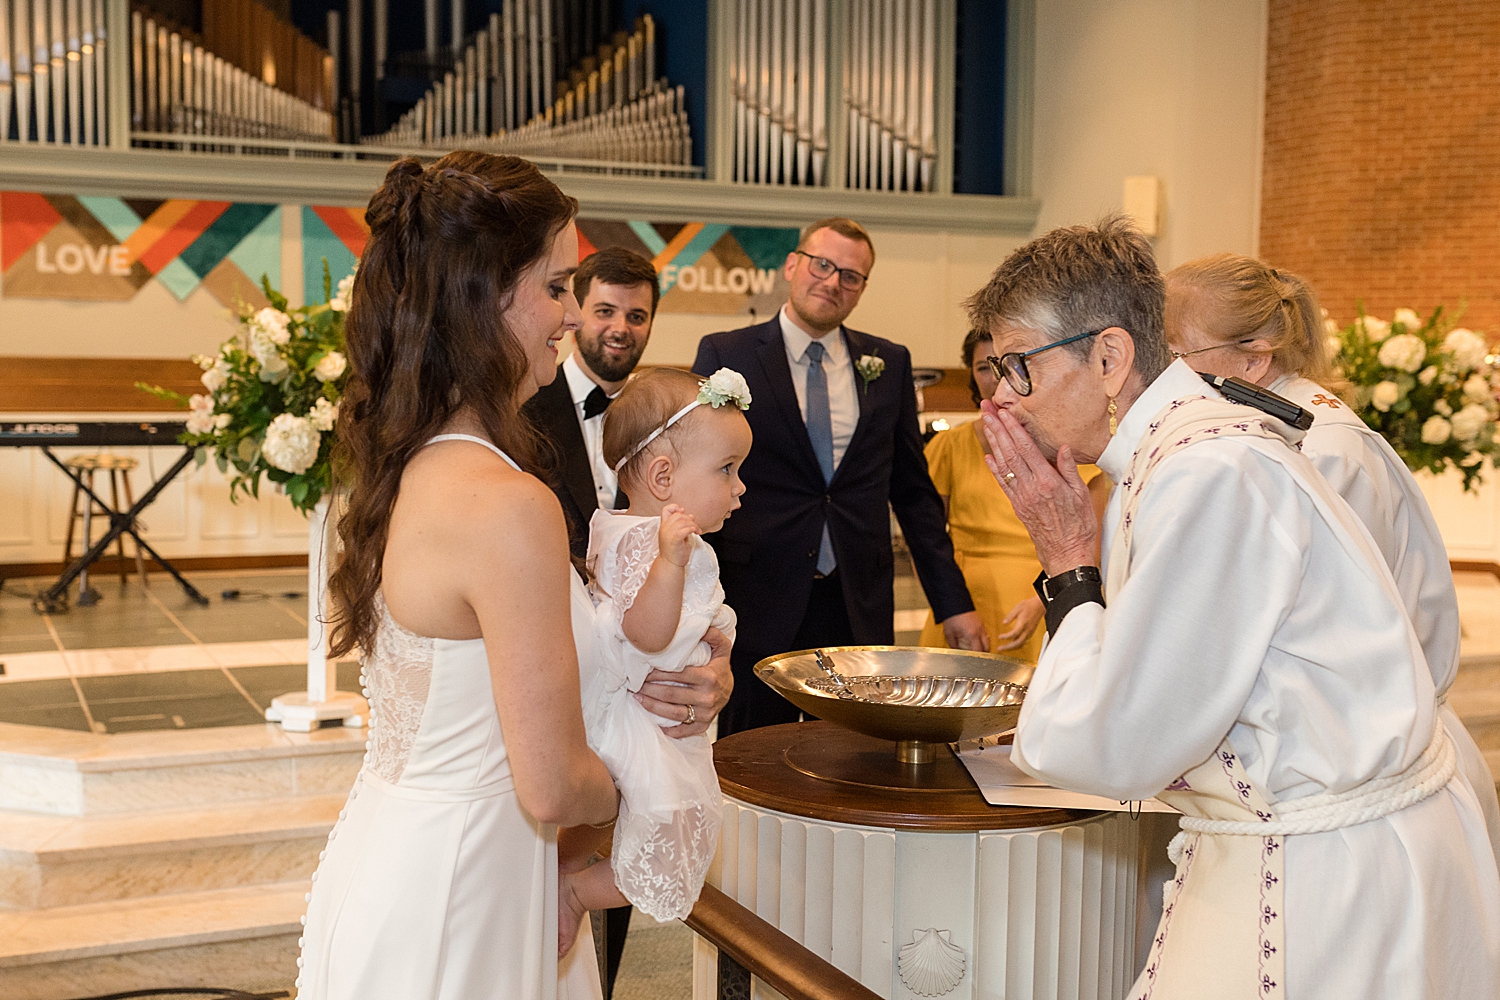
[920,330,1110,663]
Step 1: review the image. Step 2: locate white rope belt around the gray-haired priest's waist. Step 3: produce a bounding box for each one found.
[1181,720,1458,837]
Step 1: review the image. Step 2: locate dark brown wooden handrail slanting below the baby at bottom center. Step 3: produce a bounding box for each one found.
[683,885,879,1000]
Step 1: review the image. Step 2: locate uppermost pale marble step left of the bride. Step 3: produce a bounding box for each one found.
[0,724,365,816]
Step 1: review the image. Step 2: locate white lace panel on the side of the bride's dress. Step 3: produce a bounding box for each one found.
[365,598,432,784]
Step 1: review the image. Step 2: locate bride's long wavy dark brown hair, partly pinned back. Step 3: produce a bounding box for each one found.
[329,151,578,657]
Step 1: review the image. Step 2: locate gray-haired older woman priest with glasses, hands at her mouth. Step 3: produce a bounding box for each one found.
[969,219,1500,1000]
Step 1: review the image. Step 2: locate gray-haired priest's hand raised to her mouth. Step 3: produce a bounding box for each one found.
[981,400,1100,576]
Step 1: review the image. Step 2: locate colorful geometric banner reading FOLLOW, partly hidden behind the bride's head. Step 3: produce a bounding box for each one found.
[302,205,798,316]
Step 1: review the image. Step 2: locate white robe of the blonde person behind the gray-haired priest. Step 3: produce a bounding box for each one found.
[1269,375,1500,864]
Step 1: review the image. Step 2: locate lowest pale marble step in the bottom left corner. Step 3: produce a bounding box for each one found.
[0,882,301,1000]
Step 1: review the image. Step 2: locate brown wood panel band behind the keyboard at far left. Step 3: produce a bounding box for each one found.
[0,357,204,414]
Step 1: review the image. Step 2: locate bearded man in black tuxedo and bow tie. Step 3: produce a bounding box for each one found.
[525,247,662,559]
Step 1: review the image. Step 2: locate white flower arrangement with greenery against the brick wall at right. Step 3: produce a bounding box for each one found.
[1329,309,1500,490]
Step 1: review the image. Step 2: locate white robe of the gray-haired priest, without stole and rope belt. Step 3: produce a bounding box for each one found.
[1013,361,1500,1000]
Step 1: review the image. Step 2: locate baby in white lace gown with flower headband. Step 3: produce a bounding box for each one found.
[561,369,750,921]
